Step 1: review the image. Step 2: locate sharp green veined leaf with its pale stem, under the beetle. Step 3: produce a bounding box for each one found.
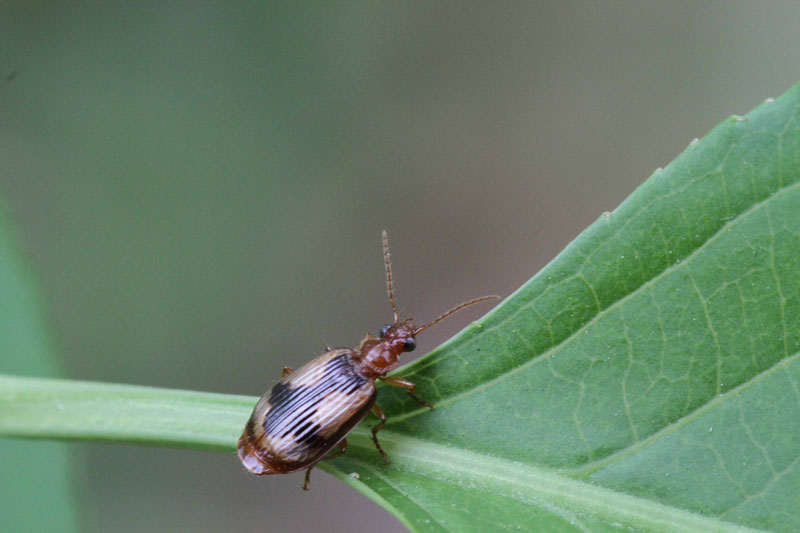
[0,85,800,531]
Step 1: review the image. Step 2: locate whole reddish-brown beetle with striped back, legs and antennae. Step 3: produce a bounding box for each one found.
[238,231,498,490]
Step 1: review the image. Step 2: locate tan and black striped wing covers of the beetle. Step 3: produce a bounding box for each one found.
[239,348,376,474]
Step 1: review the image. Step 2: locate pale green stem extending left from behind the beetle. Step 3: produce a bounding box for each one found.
[0,374,257,452]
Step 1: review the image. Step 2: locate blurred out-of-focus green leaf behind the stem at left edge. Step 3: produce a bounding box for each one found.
[0,198,81,531]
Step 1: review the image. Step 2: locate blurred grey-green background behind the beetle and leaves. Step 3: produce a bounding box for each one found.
[0,1,800,532]
